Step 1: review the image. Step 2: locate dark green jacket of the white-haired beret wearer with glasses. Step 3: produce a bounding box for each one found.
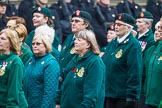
[102,33,142,99]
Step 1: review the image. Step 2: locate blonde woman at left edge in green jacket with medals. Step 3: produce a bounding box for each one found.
[0,29,28,108]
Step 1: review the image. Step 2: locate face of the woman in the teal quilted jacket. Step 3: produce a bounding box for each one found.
[32,38,46,56]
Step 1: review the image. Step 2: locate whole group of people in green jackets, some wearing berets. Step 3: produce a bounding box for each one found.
[0,3,162,108]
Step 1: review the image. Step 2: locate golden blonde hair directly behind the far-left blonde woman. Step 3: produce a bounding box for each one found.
[11,24,28,42]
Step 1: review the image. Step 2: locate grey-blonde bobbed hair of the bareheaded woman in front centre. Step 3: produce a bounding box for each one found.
[76,29,100,54]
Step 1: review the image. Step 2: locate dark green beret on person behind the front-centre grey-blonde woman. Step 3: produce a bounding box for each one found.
[72,10,92,22]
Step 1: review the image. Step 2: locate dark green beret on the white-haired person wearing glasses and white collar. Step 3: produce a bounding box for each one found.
[115,13,135,26]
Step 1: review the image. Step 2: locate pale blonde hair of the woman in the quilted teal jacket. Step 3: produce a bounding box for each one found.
[33,34,52,53]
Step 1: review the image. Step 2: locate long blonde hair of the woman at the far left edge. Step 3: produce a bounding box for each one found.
[0,28,20,54]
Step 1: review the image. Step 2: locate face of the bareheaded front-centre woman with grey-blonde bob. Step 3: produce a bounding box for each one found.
[74,38,90,56]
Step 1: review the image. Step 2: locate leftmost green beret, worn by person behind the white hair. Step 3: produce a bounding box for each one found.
[32,7,52,18]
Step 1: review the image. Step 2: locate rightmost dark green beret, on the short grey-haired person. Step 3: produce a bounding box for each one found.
[136,11,153,19]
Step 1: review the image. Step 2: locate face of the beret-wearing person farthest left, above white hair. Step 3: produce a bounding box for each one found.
[33,13,48,27]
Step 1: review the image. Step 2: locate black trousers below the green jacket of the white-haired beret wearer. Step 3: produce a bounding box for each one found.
[104,97,138,108]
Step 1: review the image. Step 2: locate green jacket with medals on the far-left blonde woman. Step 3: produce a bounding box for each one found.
[0,52,28,108]
